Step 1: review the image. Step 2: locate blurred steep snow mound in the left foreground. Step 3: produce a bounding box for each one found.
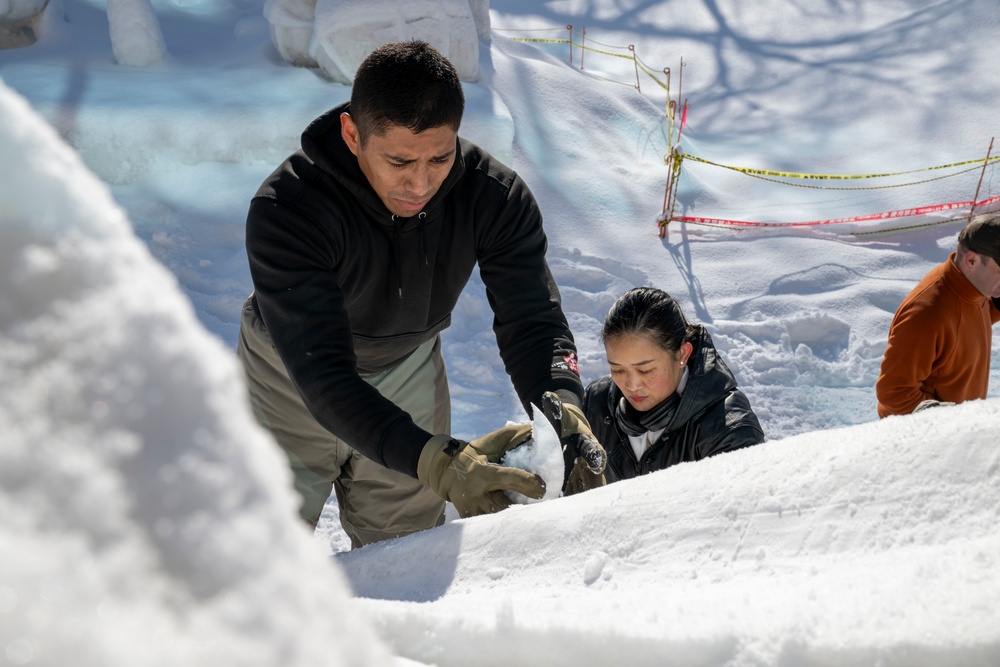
[0,83,388,667]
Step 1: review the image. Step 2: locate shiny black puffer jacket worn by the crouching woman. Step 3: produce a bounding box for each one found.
[584,326,764,482]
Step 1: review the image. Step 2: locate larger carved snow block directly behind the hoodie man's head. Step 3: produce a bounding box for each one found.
[310,0,479,84]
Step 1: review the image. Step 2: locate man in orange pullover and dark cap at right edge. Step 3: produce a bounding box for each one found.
[875,214,1000,417]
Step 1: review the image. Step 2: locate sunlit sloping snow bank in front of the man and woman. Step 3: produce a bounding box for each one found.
[338,400,1000,666]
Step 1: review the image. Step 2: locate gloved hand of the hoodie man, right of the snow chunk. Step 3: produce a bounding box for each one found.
[542,391,608,496]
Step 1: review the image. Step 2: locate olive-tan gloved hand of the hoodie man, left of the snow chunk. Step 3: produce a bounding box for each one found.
[417,424,545,517]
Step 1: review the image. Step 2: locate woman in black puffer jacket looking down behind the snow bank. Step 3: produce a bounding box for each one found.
[584,287,764,482]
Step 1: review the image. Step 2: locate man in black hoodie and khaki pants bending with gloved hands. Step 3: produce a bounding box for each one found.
[238,41,604,547]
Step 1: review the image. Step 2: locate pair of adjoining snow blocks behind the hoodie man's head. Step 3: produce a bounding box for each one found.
[264,0,489,84]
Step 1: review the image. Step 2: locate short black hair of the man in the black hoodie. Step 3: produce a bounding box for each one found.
[351,40,465,145]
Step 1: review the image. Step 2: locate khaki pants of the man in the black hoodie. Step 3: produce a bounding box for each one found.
[237,299,451,548]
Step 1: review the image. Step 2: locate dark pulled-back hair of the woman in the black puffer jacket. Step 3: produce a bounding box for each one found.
[601,287,696,353]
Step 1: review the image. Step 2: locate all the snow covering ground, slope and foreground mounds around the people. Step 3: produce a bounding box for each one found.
[0,0,1000,667]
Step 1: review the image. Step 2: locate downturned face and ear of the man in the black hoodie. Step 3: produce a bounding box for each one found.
[340,113,458,218]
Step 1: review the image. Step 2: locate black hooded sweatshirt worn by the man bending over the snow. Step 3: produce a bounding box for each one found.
[246,105,583,476]
